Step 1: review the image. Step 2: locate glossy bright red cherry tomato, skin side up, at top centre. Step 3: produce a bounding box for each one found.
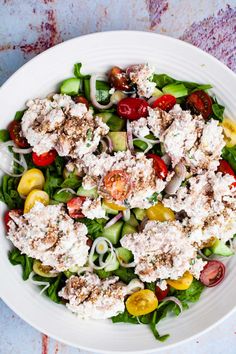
[117,97,148,120]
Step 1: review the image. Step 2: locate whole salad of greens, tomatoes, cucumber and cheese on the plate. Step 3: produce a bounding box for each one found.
[0,63,236,341]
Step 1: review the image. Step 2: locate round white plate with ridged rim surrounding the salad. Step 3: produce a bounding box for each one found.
[0,31,236,354]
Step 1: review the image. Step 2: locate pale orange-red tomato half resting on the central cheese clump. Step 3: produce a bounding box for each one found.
[104,170,131,201]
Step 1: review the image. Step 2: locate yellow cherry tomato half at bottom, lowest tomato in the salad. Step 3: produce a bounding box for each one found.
[125,289,158,316]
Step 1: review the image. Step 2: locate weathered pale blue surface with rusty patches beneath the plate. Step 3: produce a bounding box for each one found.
[0,0,236,354]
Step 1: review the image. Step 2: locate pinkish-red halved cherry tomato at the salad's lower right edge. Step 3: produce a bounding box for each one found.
[200,261,225,288]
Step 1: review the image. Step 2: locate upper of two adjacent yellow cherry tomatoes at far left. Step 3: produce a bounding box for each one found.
[17,168,45,196]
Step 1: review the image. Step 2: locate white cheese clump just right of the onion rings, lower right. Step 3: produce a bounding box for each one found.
[120,221,204,282]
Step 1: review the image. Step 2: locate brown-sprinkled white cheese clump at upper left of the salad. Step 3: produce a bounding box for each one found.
[21,94,109,158]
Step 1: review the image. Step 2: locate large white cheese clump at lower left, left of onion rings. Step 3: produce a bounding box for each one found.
[7,202,89,271]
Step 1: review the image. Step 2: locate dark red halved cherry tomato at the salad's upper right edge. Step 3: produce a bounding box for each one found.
[186,90,213,119]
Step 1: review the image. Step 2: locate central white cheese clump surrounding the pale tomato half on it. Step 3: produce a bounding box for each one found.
[83,151,166,209]
